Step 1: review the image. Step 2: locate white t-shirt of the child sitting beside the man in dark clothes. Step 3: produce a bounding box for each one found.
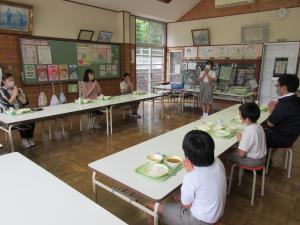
[239,123,267,159]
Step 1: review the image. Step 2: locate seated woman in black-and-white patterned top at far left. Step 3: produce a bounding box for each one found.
[0,73,35,149]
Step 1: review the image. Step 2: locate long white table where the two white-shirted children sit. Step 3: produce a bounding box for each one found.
[89,105,269,224]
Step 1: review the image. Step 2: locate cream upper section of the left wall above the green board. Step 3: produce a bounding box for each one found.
[16,0,123,43]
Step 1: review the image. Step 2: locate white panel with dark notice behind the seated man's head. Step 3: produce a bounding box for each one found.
[258,42,300,104]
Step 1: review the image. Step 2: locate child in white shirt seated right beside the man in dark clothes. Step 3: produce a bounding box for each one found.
[228,102,267,167]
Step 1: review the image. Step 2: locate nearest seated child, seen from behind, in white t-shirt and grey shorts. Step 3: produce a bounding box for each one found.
[148,130,226,225]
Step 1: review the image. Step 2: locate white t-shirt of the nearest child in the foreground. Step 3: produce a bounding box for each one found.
[181,158,227,223]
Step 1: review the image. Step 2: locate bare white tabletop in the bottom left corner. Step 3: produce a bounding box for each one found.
[0,152,126,225]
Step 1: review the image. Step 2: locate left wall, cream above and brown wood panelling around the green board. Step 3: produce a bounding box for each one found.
[0,0,135,106]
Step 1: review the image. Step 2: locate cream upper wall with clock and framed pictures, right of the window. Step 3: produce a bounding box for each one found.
[168,7,300,47]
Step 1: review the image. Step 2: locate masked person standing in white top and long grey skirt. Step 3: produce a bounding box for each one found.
[199,61,216,117]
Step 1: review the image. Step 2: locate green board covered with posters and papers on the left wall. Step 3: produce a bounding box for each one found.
[20,38,121,85]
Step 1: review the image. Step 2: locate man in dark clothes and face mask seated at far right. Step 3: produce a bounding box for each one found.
[266,75,300,148]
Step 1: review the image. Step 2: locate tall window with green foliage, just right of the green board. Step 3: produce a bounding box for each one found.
[136,18,166,92]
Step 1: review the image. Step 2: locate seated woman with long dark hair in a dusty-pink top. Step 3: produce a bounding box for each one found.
[82,69,102,129]
